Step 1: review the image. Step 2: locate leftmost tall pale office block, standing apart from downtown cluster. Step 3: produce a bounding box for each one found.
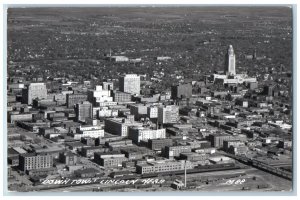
[22,83,47,105]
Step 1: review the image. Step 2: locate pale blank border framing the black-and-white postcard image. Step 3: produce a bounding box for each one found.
[0,0,300,200]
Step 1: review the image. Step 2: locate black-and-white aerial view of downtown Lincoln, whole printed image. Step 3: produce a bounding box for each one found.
[5,6,294,192]
